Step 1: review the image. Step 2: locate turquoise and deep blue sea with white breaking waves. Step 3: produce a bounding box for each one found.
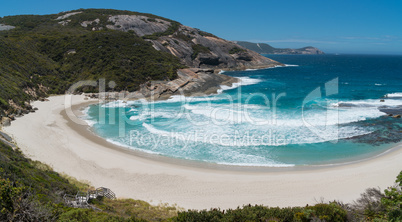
[85,55,402,167]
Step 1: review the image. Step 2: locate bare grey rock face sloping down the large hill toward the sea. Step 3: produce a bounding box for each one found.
[107,15,282,70]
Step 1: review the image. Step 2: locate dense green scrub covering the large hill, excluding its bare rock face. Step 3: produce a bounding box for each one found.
[0,9,183,116]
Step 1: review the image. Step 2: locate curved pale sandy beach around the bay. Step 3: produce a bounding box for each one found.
[3,96,402,209]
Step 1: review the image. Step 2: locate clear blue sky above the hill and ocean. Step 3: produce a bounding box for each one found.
[0,0,402,54]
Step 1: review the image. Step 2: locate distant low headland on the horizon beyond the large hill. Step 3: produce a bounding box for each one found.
[235,41,325,55]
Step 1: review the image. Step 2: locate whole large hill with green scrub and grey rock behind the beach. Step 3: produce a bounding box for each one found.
[0,9,280,121]
